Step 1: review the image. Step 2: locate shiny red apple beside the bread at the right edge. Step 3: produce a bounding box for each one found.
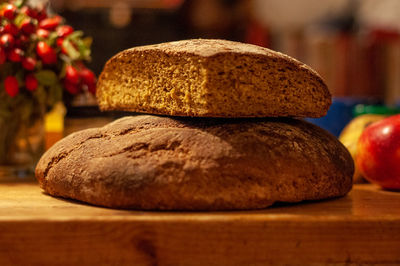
[356,115,400,190]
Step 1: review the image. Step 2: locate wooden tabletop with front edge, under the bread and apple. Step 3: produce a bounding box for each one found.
[0,178,400,265]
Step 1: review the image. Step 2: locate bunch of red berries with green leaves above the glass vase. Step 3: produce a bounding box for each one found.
[0,1,96,115]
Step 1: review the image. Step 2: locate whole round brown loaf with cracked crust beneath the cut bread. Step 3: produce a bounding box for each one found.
[36,115,354,210]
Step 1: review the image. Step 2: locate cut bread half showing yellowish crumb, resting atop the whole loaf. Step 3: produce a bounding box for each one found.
[97,39,331,117]
